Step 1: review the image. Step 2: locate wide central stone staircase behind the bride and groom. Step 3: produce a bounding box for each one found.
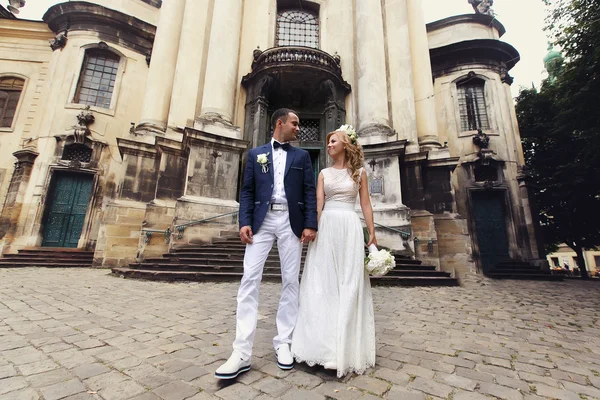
[112,237,458,286]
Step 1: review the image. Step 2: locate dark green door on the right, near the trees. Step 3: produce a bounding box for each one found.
[472,191,509,273]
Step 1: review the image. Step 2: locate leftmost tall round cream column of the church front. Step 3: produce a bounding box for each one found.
[138,0,185,132]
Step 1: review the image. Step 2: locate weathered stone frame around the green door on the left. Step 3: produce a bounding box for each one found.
[35,165,99,249]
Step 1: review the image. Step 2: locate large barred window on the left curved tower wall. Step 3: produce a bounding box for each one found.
[73,49,120,108]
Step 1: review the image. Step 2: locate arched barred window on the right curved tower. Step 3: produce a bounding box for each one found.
[457,78,490,131]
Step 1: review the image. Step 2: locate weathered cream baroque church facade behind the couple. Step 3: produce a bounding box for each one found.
[0,0,541,275]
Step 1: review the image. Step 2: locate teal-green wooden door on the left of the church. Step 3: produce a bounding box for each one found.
[42,172,93,247]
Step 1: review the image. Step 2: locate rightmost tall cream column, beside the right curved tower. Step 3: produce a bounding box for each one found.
[406,0,440,149]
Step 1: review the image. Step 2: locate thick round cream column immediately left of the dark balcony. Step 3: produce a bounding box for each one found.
[200,0,242,123]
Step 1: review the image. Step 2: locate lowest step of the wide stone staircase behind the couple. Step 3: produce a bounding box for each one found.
[112,268,458,286]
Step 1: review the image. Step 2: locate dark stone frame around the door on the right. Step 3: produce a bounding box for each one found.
[467,187,518,273]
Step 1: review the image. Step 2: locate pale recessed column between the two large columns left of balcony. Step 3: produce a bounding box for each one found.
[169,0,210,127]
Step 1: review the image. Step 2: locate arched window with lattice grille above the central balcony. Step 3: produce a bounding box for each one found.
[275,9,319,49]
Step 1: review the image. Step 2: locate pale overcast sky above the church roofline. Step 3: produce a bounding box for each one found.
[11,0,548,97]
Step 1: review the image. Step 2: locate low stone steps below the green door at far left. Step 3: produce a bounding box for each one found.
[0,247,94,268]
